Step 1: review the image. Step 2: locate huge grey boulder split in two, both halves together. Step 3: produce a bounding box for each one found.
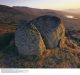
[15,15,65,55]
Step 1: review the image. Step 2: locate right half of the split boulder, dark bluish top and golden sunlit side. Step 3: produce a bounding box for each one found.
[30,15,65,48]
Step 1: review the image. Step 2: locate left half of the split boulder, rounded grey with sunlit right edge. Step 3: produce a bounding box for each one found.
[15,22,46,55]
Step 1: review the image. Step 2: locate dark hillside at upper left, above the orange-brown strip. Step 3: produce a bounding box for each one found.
[0,5,26,24]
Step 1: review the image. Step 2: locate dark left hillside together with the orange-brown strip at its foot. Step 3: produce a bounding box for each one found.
[0,5,27,34]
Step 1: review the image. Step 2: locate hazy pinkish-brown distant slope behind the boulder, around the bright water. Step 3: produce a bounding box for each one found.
[13,6,80,30]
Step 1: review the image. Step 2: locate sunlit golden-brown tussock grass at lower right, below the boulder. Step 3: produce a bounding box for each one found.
[39,39,80,68]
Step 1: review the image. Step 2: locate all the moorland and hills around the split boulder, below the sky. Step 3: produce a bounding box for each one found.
[0,5,80,68]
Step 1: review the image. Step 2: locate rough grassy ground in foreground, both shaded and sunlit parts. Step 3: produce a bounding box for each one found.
[0,34,80,68]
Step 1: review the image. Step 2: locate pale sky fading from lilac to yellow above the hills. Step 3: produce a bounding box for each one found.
[0,0,80,10]
